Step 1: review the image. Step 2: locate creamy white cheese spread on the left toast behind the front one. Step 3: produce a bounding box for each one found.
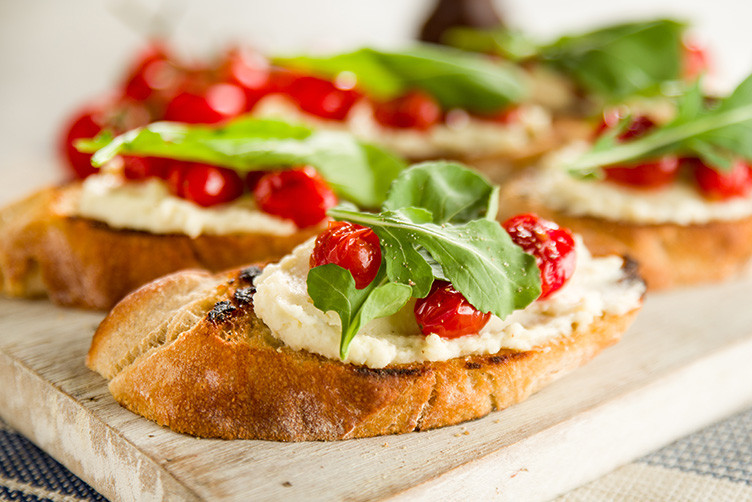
[70,173,297,237]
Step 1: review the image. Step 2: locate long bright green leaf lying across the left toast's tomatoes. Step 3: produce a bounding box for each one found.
[76,117,406,207]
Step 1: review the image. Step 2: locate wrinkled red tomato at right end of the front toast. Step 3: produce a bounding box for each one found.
[502,213,576,299]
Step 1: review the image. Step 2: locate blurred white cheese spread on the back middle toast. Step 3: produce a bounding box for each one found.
[253,94,551,158]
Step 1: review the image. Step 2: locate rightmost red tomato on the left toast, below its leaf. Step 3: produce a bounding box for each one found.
[253,166,337,228]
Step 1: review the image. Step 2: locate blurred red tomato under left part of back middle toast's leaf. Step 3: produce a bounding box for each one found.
[284,75,361,120]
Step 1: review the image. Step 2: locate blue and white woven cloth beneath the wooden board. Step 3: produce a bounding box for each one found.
[0,408,752,502]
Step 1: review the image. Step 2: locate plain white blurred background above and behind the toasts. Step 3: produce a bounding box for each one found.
[0,0,752,188]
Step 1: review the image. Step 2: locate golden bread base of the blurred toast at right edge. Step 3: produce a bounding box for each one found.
[499,176,752,291]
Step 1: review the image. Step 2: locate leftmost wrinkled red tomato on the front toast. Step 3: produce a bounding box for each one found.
[310,221,381,289]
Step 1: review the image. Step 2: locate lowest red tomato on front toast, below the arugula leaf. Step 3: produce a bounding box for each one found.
[414,281,491,338]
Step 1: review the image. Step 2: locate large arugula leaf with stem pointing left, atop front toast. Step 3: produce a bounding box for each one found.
[329,207,541,318]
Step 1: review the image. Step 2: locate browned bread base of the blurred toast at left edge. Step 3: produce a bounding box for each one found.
[0,185,319,309]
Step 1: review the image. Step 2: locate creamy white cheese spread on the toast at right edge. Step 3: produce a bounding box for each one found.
[521,144,752,225]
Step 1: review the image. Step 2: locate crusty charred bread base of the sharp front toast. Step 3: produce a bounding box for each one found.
[86,262,640,441]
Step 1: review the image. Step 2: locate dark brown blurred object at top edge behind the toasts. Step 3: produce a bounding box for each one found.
[419,0,503,44]
